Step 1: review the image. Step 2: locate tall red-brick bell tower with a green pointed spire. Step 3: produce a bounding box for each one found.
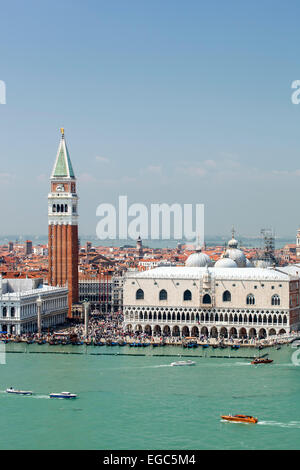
[48,128,78,318]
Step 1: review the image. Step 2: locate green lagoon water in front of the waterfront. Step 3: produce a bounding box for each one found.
[0,344,300,450]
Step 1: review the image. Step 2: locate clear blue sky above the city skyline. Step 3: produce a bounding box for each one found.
[0,0,300,241]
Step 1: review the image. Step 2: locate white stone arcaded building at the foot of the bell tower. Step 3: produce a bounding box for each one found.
[0,277,68,335]
